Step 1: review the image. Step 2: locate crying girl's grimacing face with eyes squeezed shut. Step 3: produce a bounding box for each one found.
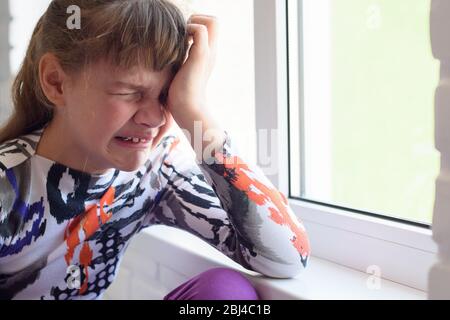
[59,61,173,175]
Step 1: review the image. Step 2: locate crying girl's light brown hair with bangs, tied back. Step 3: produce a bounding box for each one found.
[0,0,188,143]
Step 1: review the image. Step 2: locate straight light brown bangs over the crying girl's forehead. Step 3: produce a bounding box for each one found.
[70,0,188,72]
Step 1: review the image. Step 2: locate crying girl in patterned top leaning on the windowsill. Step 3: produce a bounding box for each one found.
[0,0,310,299]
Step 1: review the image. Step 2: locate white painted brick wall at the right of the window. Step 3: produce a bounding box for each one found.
[429,0,450,299]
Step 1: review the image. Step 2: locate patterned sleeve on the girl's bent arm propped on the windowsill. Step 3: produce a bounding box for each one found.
[148,132,310,278]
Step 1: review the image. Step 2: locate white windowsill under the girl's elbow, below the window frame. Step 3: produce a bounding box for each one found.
[142,226,427,300]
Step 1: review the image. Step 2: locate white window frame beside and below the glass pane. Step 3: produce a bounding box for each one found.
[254,0,437,291]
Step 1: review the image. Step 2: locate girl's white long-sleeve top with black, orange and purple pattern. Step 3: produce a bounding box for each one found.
[0,128,310,299]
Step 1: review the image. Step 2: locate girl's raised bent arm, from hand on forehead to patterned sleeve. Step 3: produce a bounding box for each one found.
[148,15,310,278]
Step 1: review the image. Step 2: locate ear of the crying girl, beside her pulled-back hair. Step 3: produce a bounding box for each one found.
[39,53,68,107]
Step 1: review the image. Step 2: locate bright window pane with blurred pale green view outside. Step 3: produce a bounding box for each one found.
[289,0,439,224]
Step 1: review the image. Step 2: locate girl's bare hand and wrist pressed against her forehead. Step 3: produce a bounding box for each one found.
[167,14,218,124]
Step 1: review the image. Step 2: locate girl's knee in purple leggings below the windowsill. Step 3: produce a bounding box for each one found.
[164,268,259,300]
